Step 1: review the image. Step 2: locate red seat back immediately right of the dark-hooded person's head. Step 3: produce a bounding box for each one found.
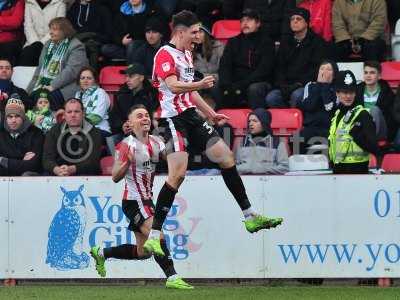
[268,108,303,136]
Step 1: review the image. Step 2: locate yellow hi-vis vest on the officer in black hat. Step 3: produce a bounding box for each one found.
[329,105,369,164]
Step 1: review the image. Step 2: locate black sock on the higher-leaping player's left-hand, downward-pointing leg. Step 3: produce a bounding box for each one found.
[152,183,177,231]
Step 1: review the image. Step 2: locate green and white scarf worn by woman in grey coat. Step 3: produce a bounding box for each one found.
[34,39,70,90]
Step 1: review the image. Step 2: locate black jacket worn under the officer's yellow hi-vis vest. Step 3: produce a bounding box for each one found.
[333,104,382,174]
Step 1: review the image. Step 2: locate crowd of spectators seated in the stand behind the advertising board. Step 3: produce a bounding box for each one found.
[0,0,400,176]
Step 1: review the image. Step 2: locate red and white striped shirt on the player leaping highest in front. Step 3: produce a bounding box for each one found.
[153,44,195,118]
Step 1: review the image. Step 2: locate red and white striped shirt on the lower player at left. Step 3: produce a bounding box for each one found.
[115,135,165,201]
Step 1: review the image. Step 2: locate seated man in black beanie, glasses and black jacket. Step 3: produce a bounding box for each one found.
[265,7,329,108]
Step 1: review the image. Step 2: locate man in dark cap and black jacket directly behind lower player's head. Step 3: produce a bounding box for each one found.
[110,63,158,139]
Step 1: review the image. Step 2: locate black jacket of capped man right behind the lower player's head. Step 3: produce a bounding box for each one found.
[110,84,158,134]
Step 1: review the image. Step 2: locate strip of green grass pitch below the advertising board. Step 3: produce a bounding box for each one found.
[0,285,400,300]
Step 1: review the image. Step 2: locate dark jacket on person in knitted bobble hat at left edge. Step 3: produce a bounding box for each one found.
[0,120,44,176]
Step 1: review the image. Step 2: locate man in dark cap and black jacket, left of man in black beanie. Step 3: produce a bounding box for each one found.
[217,9,275,109]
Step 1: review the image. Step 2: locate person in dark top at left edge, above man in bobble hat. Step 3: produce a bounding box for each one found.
[0,57,33,112]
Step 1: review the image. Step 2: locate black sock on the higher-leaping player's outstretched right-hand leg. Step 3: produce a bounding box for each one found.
[221,166,251,210]
